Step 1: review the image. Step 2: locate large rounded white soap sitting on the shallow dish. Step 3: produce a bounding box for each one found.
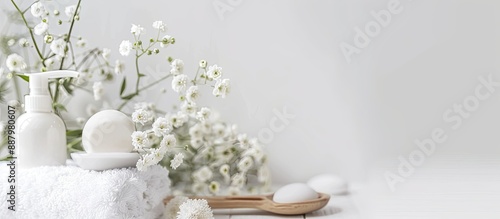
[82,110,135,153]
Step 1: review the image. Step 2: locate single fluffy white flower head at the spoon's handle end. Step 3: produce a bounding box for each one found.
[177,199,214,219]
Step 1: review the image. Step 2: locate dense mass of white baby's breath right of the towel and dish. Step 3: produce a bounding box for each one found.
[132,54,270,195]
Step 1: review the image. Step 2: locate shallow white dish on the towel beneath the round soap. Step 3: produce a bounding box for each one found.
[71,152,140,170]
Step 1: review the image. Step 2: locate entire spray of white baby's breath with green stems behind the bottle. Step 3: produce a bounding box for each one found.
[0,0,270,198]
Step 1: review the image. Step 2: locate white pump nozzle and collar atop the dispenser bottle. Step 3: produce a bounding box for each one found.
[24,70,78,112]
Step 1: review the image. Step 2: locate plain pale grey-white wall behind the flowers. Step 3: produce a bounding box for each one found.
[1,0,500,186]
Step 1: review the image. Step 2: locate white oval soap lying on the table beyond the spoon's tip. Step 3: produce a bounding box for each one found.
[307,174,347,195]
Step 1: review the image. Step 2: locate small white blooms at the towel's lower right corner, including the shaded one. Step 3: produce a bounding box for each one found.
[163,196,214,219]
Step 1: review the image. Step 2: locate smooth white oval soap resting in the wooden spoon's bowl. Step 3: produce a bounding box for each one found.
[273,183,318,203]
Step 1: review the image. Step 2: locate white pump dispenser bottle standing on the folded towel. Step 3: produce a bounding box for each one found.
[16,71,78,168]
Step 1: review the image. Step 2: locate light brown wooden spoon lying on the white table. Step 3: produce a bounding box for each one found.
[165,193,330,215]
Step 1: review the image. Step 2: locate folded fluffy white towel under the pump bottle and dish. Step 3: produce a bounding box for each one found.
[0,163,170,219]
